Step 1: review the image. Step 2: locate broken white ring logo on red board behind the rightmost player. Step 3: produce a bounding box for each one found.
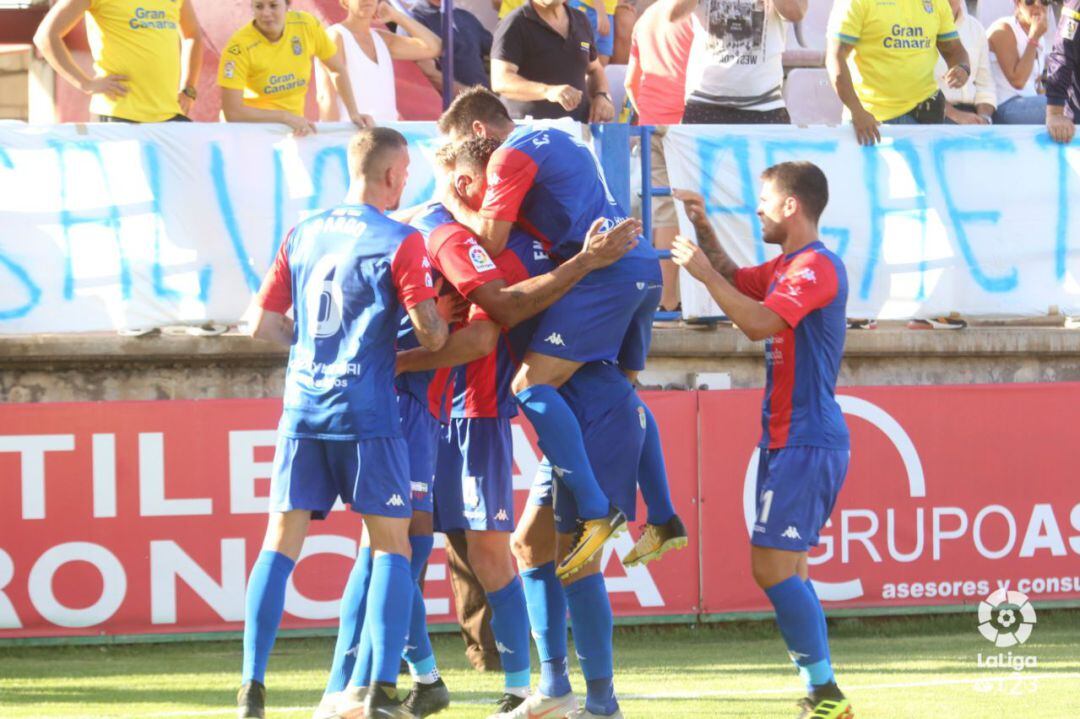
[743,395,927,601]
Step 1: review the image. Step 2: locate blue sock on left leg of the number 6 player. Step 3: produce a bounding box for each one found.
[242,550,296,684]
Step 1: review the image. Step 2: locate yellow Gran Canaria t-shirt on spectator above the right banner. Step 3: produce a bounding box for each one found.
[828,0,959,122]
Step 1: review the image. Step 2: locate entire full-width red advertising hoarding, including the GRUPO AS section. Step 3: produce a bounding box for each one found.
[0,383,1080,638]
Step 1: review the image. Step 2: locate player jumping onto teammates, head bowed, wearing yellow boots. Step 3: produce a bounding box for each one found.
[438,87,685,578]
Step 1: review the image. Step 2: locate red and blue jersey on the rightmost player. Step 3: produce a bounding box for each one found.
[735,241,850,449]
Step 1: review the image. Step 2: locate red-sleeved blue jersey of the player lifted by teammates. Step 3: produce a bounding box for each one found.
[480,125,659,272]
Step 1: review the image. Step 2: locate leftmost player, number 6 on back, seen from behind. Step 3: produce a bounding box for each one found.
[238,127,447,719]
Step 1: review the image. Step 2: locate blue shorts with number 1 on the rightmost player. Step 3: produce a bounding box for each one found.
[751,447,851,552]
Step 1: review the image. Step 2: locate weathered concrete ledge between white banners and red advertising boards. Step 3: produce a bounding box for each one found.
[0,327,1080,402]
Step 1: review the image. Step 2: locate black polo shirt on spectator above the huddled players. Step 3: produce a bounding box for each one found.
[491,0,596,122]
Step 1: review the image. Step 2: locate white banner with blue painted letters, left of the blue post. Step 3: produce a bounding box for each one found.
[0,122,440,334]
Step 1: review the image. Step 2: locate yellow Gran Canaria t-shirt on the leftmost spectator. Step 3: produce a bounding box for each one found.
[86,0,185,122]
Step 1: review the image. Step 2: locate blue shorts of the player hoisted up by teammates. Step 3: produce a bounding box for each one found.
[529,258,662,371]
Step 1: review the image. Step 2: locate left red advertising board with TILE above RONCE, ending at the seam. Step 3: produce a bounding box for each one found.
[0,393,701,637]
